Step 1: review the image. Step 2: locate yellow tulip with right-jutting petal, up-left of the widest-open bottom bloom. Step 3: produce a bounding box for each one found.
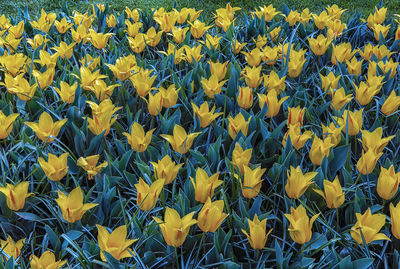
[56,186,98,223]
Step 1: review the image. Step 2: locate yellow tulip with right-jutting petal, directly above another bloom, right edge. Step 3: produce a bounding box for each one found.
[358,127,395,153]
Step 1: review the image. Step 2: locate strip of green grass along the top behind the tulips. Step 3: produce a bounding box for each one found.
[0,0,400,17]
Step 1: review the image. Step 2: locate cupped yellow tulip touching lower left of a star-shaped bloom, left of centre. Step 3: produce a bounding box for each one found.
[135,178,164,211]
